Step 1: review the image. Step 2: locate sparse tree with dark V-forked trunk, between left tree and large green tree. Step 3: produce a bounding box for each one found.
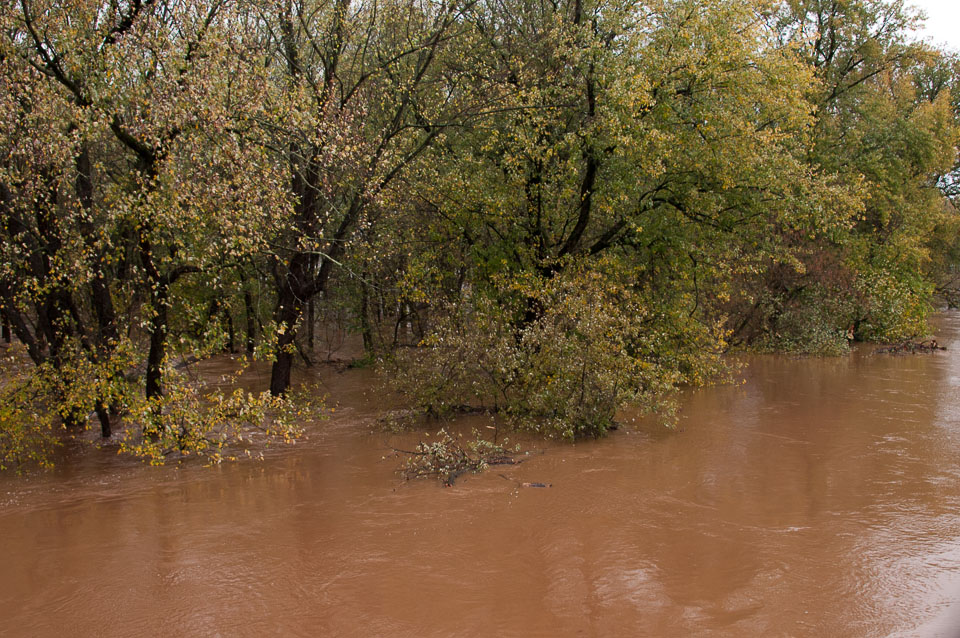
[249,0,480,394]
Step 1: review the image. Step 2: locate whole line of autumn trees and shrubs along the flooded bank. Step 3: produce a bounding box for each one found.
[0,0,960,466]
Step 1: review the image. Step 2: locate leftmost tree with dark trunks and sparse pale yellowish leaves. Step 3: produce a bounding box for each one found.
[0,0,304,464]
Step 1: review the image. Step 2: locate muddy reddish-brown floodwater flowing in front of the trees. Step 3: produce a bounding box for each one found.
[0,314,960,638]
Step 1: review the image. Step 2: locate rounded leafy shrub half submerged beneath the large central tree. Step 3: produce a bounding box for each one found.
[395,265,725,439]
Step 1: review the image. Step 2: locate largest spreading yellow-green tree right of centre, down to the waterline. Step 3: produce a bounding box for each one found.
[394,1,842,435]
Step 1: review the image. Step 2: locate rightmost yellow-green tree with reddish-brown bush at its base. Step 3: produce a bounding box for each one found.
[740,0,956,351]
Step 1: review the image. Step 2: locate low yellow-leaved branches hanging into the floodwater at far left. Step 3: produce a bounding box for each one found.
[0,348,314,470]
